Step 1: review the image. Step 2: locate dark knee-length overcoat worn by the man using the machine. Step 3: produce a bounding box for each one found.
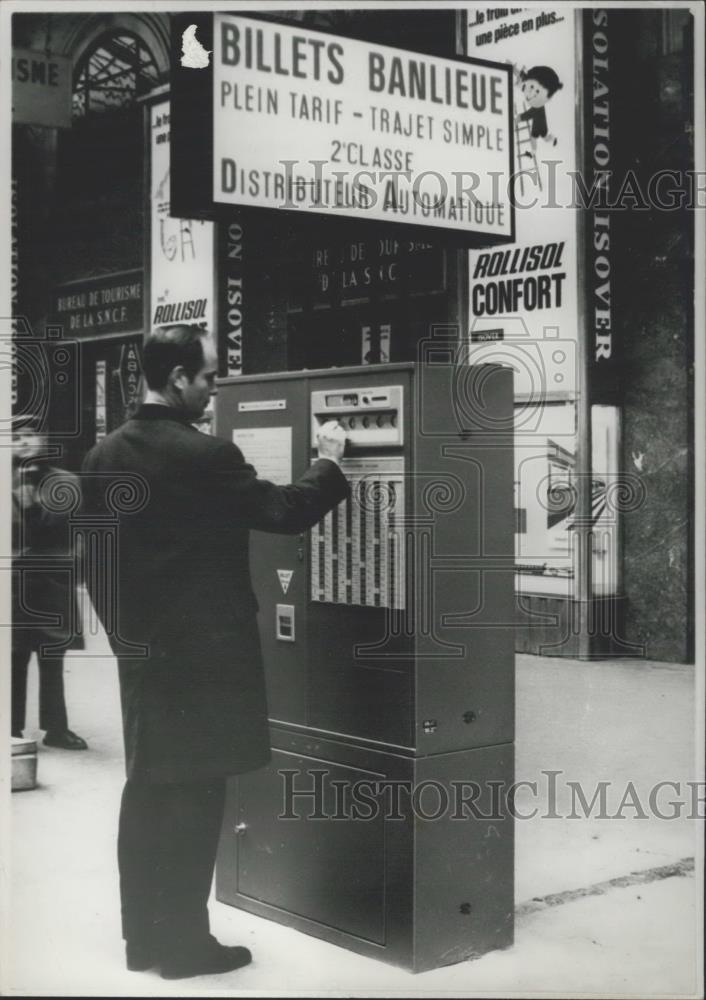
[83,404,349,782]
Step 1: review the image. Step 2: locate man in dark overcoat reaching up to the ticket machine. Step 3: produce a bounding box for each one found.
[83,326,349,978]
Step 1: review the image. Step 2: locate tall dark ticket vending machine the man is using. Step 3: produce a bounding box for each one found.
[216,350,514,971]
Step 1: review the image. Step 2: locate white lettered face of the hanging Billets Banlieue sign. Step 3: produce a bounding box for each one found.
[213,14,513,240]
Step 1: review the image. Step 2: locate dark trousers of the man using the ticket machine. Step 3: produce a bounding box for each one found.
[118,778,225,955]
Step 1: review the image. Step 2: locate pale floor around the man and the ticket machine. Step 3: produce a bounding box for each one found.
[2,616,703,997]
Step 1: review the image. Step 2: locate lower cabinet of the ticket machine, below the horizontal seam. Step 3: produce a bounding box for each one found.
[216,727,514,972]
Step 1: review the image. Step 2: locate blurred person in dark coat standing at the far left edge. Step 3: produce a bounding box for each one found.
[12,414,87,750]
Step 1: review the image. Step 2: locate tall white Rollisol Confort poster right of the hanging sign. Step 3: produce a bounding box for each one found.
[467,5,578,400]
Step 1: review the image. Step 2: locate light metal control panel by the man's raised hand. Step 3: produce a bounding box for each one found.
[311,385,404,448]
